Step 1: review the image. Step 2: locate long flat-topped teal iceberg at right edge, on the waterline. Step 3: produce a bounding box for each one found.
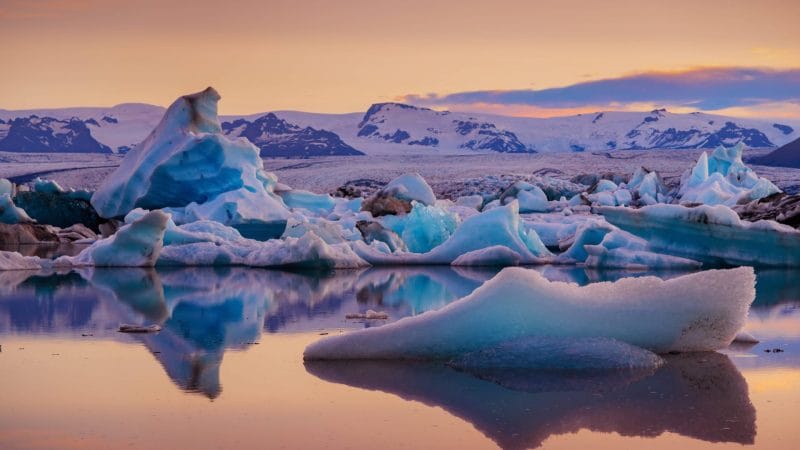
[600,205,800,267]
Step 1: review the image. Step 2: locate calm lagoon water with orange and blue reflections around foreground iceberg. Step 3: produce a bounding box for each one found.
[0,267,800,449]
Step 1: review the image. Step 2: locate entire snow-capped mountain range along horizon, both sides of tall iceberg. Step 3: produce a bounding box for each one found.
[0,103,800,157]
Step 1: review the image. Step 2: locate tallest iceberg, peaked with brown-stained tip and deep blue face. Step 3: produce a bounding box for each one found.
[92,88,288,237]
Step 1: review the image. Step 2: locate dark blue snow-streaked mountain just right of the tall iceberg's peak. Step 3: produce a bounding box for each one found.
[222,113,364,157]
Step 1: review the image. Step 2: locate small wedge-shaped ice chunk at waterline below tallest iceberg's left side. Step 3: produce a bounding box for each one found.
[63,211,169,267]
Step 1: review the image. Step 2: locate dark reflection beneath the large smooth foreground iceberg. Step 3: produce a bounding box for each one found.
[306,353,756,449]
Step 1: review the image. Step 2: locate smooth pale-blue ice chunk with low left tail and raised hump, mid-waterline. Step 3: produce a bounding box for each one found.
[353,202,552,265]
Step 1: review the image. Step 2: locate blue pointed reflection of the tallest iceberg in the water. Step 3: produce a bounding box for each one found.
[88,269,266,398]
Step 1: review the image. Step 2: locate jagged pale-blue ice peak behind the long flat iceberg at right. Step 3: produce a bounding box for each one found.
[679,143,781,206]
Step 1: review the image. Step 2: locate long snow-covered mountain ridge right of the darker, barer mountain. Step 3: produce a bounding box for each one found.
[276,103,800,154]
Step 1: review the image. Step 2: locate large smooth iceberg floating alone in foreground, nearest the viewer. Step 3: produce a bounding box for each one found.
[304,267,755,360]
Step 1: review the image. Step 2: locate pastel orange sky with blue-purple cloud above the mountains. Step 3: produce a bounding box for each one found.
[0,0,800,118]
